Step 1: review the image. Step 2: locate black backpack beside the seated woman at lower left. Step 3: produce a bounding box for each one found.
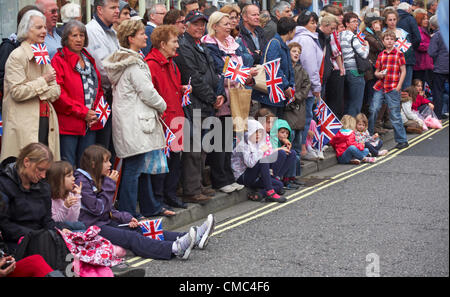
[14,229,72,273]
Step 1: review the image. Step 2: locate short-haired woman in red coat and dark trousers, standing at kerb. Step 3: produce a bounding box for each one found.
[145,25,187,208]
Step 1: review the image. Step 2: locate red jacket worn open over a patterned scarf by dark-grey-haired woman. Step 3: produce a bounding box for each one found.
[52,47,103,136]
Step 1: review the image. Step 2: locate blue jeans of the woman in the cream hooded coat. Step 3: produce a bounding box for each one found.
[118,154,162,218]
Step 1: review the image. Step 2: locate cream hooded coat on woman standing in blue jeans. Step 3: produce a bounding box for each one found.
[103,47,167,158]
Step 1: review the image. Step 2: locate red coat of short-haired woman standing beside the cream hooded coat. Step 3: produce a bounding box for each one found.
[145,48,184,151]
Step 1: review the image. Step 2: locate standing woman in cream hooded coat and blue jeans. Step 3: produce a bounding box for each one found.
[103,20,175,219]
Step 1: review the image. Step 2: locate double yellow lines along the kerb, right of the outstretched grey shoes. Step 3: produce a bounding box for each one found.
[212,121,449,236]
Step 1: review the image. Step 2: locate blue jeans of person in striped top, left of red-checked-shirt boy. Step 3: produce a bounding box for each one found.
[344,70,366,117]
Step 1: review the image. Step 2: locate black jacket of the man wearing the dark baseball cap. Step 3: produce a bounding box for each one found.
[174,33,223,119]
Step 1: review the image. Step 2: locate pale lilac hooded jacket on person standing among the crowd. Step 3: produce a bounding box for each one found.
[291,26,323,97]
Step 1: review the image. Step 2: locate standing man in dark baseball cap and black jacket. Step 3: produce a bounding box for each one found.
[174,11,225,203]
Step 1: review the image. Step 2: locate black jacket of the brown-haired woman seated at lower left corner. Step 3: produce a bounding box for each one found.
[0,158,55,244]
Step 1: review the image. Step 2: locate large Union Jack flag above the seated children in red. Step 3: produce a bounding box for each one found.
[313,98,342,151]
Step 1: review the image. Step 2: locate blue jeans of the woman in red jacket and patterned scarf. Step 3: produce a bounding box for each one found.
[59,130,97,167]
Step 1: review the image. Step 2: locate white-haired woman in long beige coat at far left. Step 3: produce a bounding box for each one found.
[1,10,60,160]
